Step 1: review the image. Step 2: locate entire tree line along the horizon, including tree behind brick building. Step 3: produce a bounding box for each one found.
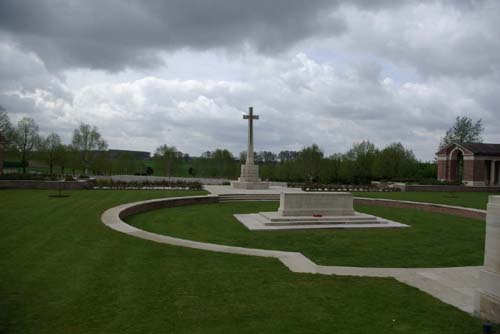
[0,110,483,184]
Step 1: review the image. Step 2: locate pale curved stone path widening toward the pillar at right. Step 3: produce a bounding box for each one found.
[101,195,481,313]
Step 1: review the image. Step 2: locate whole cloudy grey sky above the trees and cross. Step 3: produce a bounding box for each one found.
[0,0,500,161]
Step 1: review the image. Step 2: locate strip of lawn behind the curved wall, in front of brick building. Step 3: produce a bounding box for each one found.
[353,192,500,210]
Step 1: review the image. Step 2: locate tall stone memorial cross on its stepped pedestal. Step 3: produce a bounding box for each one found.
[231,107,269,189]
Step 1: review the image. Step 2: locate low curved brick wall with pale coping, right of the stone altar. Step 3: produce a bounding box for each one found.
[354,197,486,220]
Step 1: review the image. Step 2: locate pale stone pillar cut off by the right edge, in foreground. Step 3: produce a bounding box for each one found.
[475,196,500,323]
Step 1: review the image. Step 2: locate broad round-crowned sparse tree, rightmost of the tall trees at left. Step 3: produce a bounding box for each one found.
[71,123,108,174]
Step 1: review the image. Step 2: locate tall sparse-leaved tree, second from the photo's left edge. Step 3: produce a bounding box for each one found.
[12,117,40,173]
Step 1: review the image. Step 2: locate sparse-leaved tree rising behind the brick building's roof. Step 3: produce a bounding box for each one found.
[439,116,484,149]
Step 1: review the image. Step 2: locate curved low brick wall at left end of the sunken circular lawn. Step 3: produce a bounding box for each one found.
[119,195,219,219]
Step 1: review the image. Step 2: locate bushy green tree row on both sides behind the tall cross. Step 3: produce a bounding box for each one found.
[155,141,436,184]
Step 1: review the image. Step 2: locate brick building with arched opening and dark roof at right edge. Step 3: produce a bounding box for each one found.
[436,143,500,187]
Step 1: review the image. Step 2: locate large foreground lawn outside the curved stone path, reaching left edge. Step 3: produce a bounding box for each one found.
[0,190,480,334]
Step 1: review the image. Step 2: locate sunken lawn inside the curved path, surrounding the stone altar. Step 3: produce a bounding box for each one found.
[127,202,485,267]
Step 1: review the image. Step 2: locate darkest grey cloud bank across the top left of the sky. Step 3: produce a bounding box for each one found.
[0,0,343,70]
